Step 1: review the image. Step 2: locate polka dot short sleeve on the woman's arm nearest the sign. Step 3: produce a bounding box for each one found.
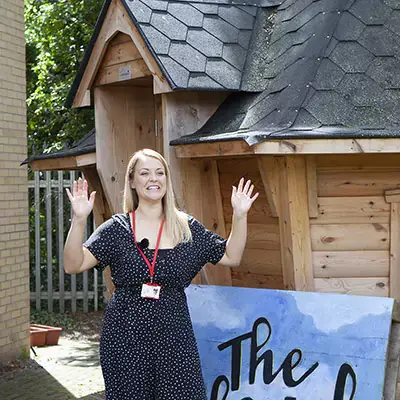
[189,218,227,265]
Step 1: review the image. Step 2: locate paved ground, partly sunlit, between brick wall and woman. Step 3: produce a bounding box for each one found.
[0,337,105,400]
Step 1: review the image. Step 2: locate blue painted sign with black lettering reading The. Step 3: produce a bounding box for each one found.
[187,285,393,400]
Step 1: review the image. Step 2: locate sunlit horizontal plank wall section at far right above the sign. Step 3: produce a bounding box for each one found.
[310,154,400,297]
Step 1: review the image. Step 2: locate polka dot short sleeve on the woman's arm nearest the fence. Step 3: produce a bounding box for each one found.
[83,217,120,271]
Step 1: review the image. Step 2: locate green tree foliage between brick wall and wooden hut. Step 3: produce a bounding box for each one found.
[25,0,102,155]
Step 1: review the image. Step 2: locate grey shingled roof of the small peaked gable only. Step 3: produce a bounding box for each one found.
[67,0,282,106]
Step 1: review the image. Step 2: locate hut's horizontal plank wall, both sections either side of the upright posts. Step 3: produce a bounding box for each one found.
[217,154,400,298]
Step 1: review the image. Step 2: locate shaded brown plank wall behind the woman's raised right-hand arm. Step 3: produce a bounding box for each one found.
[218,156,283,289]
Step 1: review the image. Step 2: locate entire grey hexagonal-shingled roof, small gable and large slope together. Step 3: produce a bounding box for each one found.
[62,0,400,145]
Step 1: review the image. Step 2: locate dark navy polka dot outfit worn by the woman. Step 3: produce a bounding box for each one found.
[84,214,226,400]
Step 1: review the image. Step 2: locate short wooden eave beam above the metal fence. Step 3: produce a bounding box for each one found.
[29,153,96,171]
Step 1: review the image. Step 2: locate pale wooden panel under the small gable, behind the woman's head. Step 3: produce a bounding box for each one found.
[94,86,159,213]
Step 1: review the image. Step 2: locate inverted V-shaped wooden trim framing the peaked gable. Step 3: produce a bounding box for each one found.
[72,0,172,108]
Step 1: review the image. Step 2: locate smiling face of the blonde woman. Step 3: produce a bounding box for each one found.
[131,156,167,202]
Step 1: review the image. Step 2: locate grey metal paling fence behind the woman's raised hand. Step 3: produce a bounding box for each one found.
[29,171,104,313]
